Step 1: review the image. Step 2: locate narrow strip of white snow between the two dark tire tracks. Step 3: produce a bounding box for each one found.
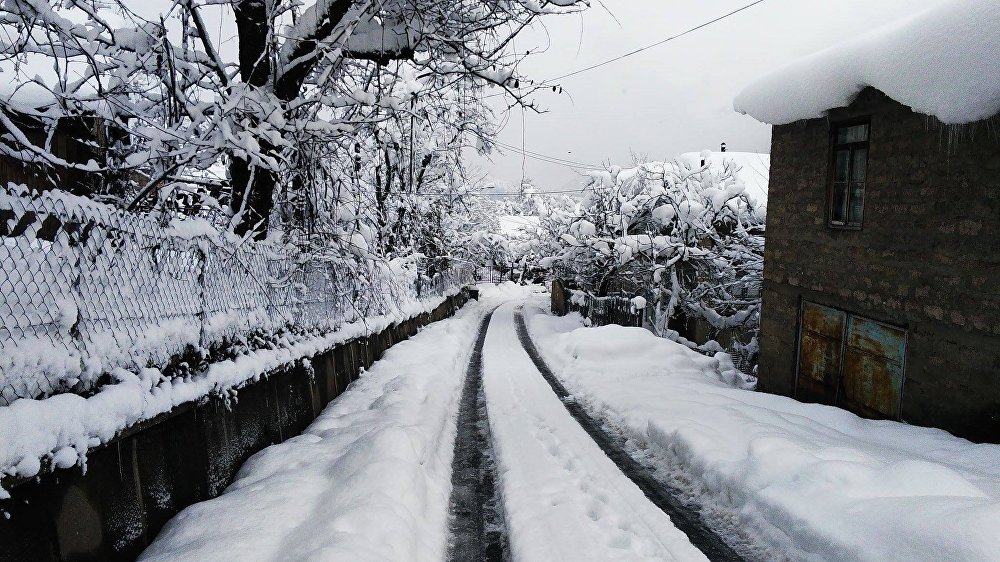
[484,303,706,561]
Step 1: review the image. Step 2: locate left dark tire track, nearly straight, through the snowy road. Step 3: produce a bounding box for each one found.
[448,309,509,562]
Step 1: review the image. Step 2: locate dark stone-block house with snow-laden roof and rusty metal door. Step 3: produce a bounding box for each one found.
[735,1,1000,442]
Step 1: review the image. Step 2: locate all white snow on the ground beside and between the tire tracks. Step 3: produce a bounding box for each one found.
[142,285,1000,562]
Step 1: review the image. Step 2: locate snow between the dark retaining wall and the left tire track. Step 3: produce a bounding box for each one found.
[140,285,523,562]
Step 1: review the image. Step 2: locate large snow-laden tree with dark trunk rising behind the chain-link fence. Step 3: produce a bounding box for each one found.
[0,0,585,237]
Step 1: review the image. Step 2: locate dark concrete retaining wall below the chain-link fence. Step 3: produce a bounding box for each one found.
[0,291,468,561]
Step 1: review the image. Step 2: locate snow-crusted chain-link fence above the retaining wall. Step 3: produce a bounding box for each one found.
[0,185,472,406]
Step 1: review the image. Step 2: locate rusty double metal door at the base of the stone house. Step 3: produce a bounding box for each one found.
[796,302,906,419]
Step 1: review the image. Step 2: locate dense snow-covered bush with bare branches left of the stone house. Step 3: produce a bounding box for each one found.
[540,153,764,346]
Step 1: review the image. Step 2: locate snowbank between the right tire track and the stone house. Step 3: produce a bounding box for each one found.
[529,306,1000,561]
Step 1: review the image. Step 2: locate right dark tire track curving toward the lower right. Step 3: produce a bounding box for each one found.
[514,307,743,562]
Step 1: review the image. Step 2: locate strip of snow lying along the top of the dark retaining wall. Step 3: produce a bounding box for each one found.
[0,288,459,498]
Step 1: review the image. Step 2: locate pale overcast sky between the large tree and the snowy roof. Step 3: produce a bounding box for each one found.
[473,0,941,191]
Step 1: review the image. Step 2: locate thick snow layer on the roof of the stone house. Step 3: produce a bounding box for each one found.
[733,0,1000,125]
